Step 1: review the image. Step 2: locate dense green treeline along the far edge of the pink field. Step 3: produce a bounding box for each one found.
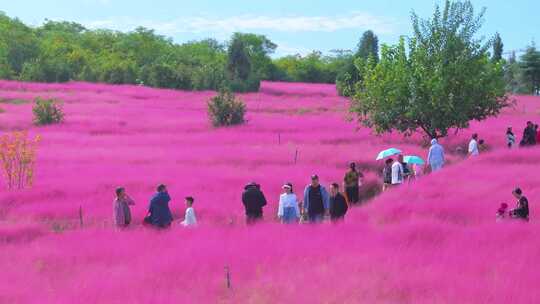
[0,12,540,96]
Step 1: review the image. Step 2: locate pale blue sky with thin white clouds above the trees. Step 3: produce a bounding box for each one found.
[0,0,540,56]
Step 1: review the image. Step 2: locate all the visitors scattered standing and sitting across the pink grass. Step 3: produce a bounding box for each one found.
[114,121,540,228]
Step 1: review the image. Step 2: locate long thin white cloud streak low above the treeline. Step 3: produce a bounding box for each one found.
[83,11,397,35]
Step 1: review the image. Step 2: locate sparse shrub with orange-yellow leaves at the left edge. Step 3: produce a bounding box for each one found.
[0,132,39,189]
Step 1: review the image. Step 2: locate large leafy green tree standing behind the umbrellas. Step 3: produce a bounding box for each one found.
[352,1,508,138]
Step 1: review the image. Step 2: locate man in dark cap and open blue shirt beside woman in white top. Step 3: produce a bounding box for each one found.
[304,175,330,223]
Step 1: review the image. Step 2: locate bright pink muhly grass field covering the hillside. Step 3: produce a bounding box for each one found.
[0,81,540,303]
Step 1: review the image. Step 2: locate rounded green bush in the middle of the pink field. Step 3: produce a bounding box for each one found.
[208,90,246,127]
